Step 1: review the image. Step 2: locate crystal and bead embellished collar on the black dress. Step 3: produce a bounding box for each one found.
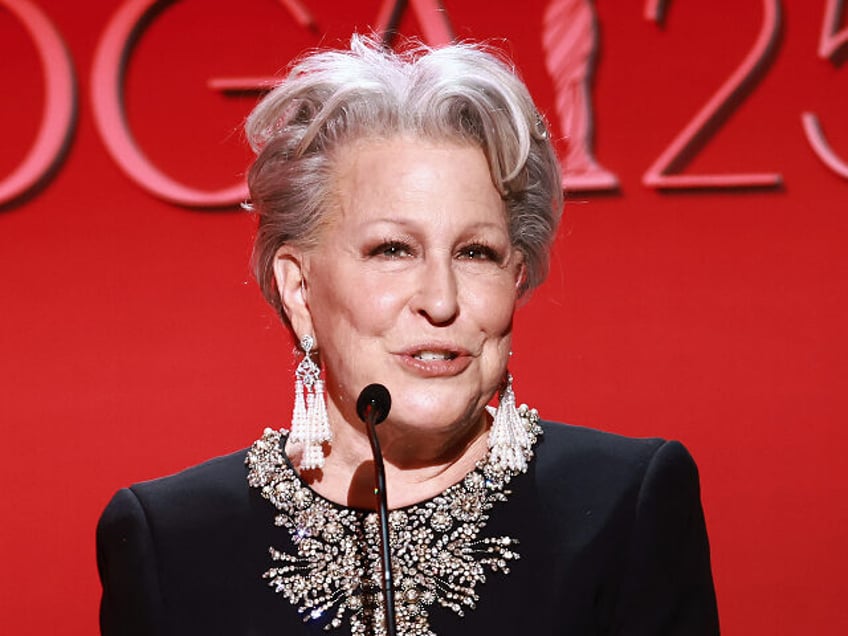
[246,405,542,636]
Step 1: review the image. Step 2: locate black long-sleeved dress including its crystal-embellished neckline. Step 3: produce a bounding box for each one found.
[97,422,719,636]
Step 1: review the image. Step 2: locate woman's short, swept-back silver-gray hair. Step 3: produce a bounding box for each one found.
[245,35,563,320]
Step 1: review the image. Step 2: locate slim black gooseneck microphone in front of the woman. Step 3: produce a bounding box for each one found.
[356,384,397,636]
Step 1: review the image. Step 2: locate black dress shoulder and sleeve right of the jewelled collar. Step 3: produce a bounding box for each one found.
[516,422,718,636]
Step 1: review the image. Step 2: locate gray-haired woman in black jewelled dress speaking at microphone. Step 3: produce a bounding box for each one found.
[98,37,718,636]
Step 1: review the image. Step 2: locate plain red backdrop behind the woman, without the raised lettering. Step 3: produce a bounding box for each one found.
[0,0,848,636]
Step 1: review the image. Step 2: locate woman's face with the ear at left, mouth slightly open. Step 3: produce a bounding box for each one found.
[277,138,523,442]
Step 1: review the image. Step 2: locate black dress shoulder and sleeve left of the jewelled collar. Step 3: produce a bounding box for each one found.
[97,450,278,635]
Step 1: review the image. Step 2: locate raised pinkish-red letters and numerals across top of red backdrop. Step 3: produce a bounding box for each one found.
[0,0,848,208]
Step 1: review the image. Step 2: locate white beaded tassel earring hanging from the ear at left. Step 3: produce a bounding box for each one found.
[289,334,333,470]
